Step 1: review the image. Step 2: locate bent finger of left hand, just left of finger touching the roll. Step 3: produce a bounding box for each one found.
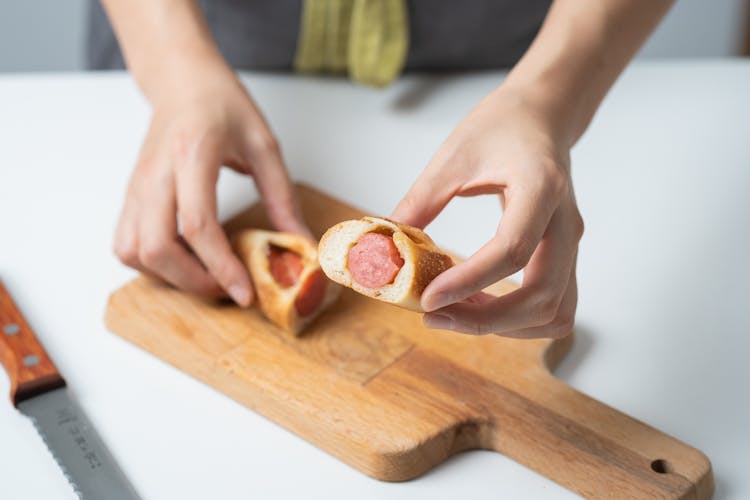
[139,173,222,296]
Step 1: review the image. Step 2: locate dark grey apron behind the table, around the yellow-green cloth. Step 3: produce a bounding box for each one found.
[87,0,551,71]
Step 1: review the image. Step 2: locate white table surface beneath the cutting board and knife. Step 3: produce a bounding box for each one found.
[0,60,750,500]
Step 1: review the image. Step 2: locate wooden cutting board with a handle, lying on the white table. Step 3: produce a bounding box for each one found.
[106,186,713,499]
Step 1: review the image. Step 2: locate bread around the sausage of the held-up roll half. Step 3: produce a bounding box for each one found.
[318,217,453,312]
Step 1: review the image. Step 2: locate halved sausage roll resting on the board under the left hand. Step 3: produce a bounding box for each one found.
[233,229,341,335]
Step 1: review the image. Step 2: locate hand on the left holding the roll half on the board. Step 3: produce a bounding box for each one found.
[114,63,310,306]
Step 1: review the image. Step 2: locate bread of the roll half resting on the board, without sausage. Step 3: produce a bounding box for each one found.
[232,229,341,335]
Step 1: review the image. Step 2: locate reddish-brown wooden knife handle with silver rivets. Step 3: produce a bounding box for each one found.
[0,282,65,406]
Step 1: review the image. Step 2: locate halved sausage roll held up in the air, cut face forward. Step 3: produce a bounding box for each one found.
[318,217,453,312]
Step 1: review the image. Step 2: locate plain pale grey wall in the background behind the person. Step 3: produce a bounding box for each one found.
[0,0,749,71]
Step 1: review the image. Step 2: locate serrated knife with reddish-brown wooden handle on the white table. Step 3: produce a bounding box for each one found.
[0,282,139,500]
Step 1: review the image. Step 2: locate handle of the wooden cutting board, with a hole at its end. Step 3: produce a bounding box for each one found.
[485,373,714,500]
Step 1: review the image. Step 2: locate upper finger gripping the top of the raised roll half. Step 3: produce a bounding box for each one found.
[390,152,460,229]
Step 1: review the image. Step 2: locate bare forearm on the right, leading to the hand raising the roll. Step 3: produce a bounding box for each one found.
[503,0,673,146]
